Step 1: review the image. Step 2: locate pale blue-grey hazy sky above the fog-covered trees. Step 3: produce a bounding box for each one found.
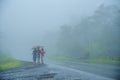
[0,0,115,59]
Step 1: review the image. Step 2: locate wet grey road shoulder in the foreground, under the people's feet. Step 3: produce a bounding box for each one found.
[0,62,115,80]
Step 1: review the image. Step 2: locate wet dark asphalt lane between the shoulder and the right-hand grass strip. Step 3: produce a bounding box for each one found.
[49,60,120,80]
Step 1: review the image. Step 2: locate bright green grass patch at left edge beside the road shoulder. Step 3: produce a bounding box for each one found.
[0,58,22,70]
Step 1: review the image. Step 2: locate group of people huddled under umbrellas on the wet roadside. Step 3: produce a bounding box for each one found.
[32,46,45,64]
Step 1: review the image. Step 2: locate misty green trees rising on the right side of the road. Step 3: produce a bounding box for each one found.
[57,5,120,59]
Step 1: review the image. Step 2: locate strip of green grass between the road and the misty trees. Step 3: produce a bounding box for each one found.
[47,55,120,65]
